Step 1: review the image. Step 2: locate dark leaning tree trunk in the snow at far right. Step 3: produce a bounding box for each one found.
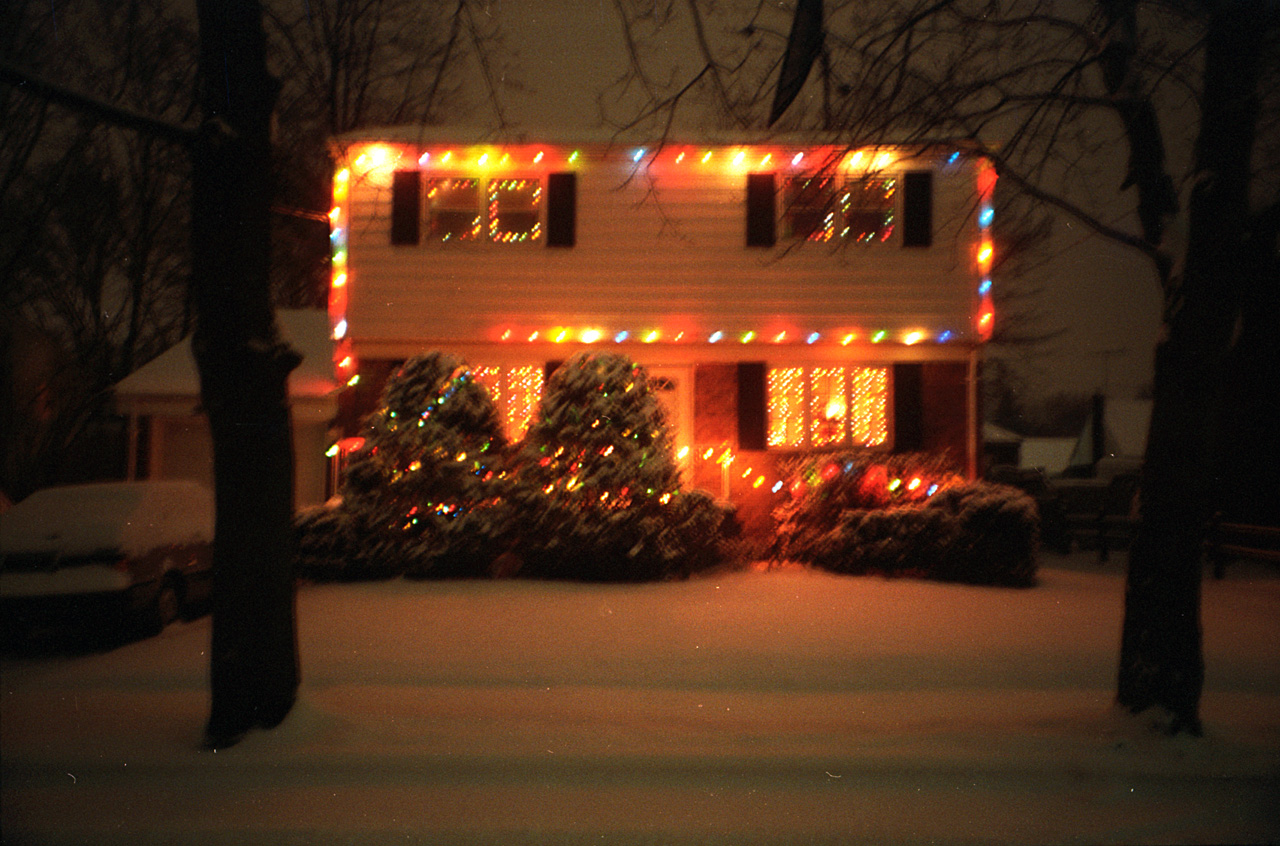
[1116,3,1265,733]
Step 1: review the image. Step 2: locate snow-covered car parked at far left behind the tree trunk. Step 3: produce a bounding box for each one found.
[0,481,214,636]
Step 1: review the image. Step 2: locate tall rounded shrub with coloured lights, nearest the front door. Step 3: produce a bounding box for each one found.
[508,353,727,581]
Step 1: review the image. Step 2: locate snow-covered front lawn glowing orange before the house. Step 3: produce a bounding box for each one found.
[0,557,1280,846]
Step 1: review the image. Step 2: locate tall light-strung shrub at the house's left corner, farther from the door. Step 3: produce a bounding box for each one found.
[342,352,506,577]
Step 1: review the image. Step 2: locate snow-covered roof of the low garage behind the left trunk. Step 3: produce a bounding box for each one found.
[115,308,338,399]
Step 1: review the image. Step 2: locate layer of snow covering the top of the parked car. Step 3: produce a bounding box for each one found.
[0,480,214,555]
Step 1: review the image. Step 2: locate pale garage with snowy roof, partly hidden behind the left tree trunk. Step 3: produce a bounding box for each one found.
[115,310,338,507]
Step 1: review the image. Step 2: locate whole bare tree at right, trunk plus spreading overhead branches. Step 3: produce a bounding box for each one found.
[606,0,1280,732]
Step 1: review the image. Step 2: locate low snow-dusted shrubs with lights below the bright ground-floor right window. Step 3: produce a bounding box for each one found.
[774,453,1038,586]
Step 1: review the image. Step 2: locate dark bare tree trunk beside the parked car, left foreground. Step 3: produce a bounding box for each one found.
[192,0,300,749]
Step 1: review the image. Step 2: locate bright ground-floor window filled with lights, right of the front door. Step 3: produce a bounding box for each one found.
[767,366,888,448]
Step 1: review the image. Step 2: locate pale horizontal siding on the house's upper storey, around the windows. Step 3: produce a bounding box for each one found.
[337,145,978,353]
